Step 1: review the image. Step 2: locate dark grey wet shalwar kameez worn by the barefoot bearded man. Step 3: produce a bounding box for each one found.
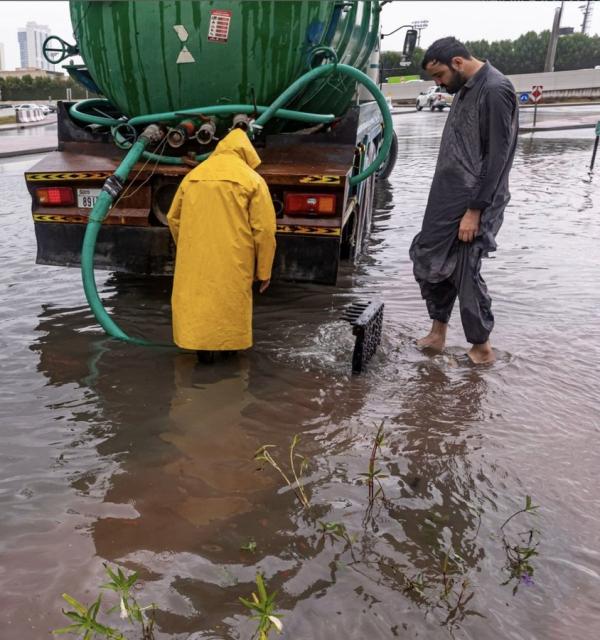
[410,62,518,344]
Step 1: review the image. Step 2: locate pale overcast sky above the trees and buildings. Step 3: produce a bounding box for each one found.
[0,0,600,69]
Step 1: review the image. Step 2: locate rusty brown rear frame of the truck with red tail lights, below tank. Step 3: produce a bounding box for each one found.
[25,102,396,285]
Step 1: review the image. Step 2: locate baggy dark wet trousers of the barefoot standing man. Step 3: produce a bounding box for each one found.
[417,242,494,344]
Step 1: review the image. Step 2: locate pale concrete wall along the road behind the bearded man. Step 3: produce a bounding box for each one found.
[382,69,600,102]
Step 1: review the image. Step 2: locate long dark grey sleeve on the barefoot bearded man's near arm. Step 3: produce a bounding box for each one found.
[469,85,517,210]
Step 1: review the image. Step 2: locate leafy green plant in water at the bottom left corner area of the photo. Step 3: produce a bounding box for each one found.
[53,564,154,640]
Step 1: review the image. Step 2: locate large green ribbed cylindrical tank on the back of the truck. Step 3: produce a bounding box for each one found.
[70,0,380,127]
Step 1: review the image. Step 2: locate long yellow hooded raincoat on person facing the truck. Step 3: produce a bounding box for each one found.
[167,129,275,351]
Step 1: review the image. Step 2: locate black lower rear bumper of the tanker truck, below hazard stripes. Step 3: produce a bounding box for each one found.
[34,222,340,284]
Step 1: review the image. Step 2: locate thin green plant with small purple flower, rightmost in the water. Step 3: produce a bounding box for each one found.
[500,496,540,595]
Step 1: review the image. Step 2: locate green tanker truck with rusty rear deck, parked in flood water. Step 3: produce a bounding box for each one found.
[25,0,414,284]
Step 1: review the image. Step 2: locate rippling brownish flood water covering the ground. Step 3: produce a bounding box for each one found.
[0,112,600,640]
